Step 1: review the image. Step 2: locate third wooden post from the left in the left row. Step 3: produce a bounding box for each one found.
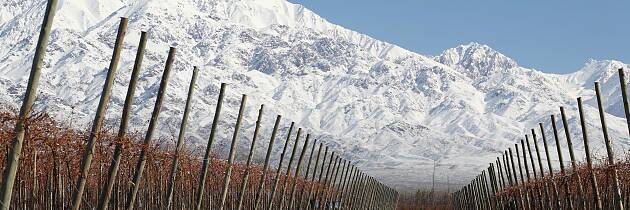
[98,31,148,210]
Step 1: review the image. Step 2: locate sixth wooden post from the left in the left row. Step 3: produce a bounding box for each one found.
[195,83,227,210]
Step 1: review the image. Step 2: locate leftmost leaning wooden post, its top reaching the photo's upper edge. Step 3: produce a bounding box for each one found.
[0,0,57,210]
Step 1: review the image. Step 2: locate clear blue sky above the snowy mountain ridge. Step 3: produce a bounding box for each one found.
[289,0,630,73]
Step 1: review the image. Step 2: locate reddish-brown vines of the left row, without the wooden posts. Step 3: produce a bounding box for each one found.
[0,113,396,209]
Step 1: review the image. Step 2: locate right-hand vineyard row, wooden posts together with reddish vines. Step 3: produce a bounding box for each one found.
[452,69,630,210]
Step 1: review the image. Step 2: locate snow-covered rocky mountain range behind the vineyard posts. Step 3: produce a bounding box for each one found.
[0,0,629,190]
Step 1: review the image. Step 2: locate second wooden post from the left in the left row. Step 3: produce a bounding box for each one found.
[72,18,128,210]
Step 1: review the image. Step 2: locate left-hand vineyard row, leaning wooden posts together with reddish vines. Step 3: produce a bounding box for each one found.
[0,0,398,210]
